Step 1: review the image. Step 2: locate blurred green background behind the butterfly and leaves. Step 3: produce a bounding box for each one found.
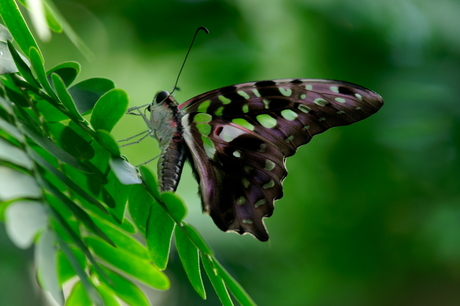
[0,0,460,306]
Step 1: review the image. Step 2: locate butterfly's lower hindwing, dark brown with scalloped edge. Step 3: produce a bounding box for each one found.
[182,113,287,241]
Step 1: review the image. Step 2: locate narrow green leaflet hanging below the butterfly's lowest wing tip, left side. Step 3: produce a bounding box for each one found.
[175,227,206,300]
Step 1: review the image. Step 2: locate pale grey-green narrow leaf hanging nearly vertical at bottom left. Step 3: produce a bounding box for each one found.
[35,230,64,305]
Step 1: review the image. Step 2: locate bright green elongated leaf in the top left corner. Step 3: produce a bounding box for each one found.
[0,0,38,54]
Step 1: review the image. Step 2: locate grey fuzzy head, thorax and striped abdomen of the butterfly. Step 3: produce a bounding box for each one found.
[148,91,185,191]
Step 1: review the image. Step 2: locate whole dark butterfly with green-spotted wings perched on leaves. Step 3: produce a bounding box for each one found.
[128,79,383,241]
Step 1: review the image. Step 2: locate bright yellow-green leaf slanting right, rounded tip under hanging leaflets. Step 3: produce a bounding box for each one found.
[85,237,170,290]
